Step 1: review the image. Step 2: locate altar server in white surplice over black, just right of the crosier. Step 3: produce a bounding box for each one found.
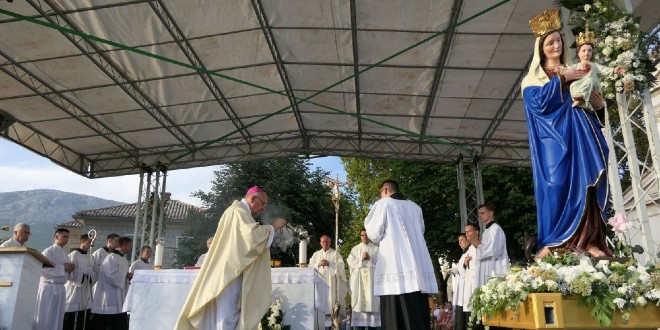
[92,237,133,330]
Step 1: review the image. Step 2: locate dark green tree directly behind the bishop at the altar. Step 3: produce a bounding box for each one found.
[176,157,354,266]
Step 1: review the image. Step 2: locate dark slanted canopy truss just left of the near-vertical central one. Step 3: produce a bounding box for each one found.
[252,0,309,143]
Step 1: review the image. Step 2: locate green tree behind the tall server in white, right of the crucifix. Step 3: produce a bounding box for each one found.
[342,158,536,300]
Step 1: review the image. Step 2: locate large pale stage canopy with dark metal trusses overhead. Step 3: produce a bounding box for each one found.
[0,0,659,178]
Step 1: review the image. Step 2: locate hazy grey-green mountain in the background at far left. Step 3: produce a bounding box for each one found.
[0,189,125,251]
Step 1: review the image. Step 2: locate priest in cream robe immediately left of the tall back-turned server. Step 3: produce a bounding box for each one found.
[347,228,380,329]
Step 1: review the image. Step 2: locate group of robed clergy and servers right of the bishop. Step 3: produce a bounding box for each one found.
[309,180,509,330]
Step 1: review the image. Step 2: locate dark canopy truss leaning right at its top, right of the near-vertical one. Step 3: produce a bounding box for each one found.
[420,0,463,136]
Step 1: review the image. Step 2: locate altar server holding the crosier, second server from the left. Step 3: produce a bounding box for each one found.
[64,234,93,330]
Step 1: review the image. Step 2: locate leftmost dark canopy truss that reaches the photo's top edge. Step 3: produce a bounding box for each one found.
[27,0,194,149]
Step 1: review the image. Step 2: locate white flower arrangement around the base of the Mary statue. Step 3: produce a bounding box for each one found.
[470,251,660,326]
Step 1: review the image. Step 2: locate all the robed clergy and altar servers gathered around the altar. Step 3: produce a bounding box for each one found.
[3,180,508,330]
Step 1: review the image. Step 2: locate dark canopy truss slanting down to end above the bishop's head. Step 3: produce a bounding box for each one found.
[149,0,250,143]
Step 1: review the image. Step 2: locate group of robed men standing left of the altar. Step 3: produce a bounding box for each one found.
[0,223,152,330]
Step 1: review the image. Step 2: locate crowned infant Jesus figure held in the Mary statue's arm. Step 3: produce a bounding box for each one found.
[571,27,626,110]
